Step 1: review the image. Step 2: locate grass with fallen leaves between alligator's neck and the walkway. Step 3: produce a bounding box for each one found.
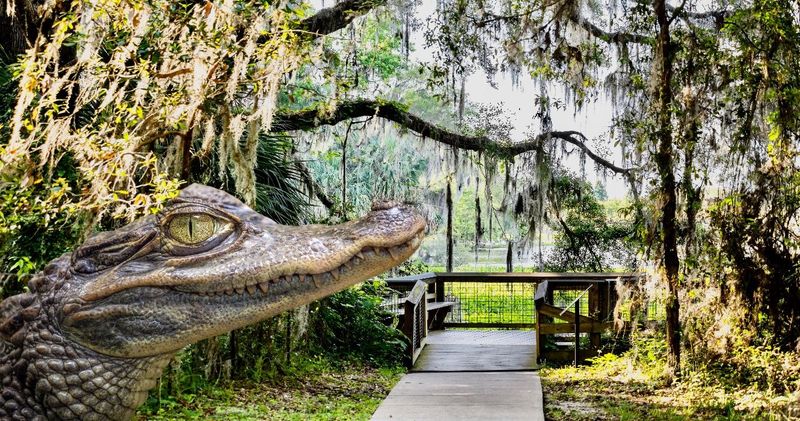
[139,366,403,421]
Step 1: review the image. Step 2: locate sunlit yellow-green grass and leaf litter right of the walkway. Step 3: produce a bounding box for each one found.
[540,340,800,421]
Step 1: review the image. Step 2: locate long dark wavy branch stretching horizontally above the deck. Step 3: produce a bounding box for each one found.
[273,99,632,175]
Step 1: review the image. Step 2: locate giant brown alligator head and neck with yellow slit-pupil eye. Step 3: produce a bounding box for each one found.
[0,184,425,420]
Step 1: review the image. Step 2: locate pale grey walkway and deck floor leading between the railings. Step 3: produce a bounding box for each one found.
[372,330,544,421]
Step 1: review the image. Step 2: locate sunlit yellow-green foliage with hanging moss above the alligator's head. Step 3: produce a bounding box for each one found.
[0,1,316,282]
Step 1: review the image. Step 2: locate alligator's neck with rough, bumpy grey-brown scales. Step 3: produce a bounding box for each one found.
[0,327,173,420]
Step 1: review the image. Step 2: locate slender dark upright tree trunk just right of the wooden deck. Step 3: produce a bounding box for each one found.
[653,0,681,375]
